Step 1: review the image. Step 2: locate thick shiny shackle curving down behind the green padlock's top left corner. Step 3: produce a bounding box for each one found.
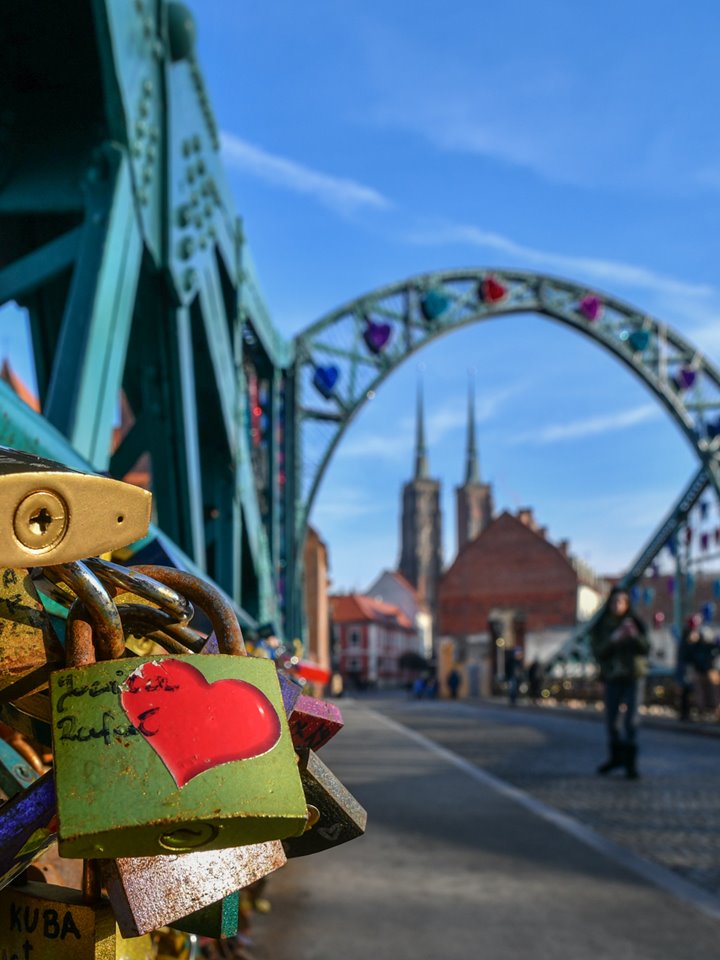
[55,561,125,665]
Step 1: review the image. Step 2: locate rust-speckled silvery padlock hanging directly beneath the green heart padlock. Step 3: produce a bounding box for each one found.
[100,840,287,937]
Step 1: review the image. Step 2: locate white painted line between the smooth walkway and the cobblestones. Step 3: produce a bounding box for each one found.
[362,707,720,920]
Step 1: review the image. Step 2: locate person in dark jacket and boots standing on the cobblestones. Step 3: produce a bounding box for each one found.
[591,588,650,780]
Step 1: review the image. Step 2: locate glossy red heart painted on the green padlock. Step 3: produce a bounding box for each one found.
[120,658,280,787]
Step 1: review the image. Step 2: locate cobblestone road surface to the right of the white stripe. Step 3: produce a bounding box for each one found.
[374,697,720,896]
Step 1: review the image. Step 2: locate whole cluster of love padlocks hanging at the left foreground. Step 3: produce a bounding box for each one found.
[0,448,366,960]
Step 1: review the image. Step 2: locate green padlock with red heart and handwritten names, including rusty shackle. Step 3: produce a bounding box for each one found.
[50,567,307,858]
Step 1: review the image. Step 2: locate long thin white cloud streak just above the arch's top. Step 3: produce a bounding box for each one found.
[407,224,715,297]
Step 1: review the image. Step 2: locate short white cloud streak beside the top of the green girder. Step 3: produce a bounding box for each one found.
[220,131,392,214]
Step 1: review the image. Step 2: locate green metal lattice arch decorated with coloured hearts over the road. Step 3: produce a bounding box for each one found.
[294,268,720,656]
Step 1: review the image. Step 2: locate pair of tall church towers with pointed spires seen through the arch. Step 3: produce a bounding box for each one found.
[398,383,493,633]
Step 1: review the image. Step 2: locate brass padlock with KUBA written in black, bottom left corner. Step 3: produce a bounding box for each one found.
[0,861,152,960]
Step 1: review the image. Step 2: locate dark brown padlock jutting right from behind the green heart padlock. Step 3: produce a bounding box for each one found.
[283,750,367,859]
